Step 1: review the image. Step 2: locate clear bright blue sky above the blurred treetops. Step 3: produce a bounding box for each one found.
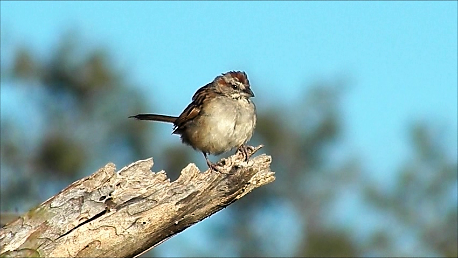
[1,1,458,256]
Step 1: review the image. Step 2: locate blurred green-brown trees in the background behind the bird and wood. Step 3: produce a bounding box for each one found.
[1,33,458,257]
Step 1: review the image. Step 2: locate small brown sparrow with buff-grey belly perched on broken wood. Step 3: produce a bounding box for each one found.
[129,71,256,170]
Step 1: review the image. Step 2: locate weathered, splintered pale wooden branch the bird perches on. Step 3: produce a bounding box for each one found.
[0,146,275,257]
